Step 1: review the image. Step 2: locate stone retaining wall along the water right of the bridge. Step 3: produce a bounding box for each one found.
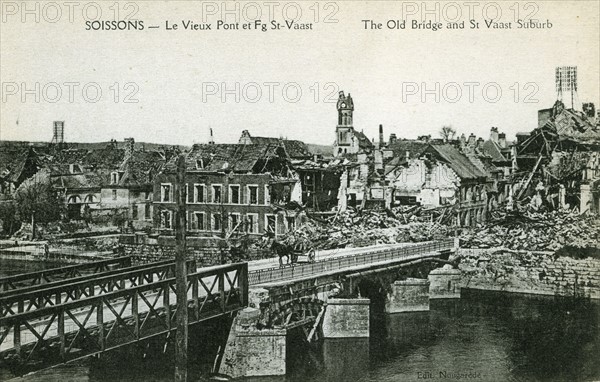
[456,248,600,300]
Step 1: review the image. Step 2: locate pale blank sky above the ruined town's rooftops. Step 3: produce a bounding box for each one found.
[0,0,600,145]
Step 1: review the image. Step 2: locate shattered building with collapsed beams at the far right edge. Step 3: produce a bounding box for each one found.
[514,101,600,213]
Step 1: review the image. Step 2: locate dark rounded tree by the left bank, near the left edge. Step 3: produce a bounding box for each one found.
[15,172,64,239]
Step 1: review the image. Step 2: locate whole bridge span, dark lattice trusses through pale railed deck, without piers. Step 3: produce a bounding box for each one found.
[0,240,454,371]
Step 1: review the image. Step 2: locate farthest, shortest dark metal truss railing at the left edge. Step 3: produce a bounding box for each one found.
[0,256,131,294]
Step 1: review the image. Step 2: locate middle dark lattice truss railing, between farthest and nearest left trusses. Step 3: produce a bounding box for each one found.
[0,260,196,317]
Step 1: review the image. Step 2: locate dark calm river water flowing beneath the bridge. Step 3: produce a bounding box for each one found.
[0,258,600,382]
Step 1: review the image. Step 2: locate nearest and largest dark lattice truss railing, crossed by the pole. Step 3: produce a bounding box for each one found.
[0,263,248,369]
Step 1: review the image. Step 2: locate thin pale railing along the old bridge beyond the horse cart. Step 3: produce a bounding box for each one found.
[248,239,454,285]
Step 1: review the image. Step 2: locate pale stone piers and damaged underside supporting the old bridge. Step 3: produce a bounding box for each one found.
[219,258,460,377]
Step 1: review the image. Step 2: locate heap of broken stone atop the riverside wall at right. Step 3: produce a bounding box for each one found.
[460,211,600,252]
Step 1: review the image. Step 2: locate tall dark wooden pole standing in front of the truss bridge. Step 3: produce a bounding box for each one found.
[173,154,188,382]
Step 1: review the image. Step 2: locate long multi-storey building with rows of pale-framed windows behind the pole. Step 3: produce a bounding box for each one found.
[153,142,302,238]
